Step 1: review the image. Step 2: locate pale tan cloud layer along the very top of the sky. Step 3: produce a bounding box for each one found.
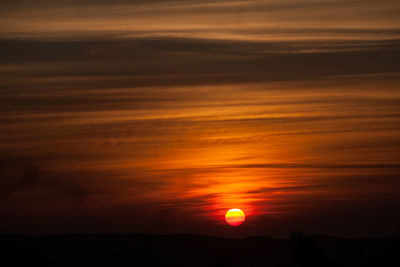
[0,0,399,40]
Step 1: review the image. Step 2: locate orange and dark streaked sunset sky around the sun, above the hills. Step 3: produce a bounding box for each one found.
[0,0,400,237]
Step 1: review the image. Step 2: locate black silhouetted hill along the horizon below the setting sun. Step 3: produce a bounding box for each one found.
[0,232,400,267]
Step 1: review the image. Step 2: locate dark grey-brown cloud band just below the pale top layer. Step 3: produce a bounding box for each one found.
[0,38,400,92]
